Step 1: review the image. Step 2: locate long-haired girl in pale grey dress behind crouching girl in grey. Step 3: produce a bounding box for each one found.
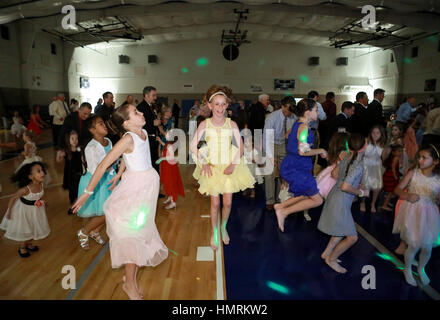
[360,125,386,213]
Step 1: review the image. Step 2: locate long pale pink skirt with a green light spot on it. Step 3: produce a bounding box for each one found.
[104,168,168,268]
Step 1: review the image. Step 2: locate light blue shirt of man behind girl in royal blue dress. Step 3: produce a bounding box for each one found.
[263,109,297,158]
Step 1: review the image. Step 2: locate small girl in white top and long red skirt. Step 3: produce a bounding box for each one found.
[157,130,185,210]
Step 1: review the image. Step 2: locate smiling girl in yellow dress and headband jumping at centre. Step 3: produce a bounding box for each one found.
[190,85,255,250]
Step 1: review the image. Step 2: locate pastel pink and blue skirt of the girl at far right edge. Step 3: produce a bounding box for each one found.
[393,196,440,248]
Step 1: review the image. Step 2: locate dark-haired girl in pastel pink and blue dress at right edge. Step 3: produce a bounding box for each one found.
[393,144,440,286]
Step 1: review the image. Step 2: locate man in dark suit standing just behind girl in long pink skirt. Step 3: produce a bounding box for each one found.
[136,86,160,173]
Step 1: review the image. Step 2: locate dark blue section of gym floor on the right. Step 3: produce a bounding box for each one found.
[223,186,440,300]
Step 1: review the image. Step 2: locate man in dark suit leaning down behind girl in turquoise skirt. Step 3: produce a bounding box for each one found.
[58,102,92,152]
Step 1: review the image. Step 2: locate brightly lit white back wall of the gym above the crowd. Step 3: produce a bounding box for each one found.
[66,39,397,104]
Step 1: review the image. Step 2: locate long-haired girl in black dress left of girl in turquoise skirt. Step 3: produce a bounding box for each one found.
[57,131,84,214]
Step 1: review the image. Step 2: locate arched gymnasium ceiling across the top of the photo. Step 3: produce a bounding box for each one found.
[0,0,440,48]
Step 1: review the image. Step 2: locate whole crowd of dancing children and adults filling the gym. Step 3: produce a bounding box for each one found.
[0,85,440,299]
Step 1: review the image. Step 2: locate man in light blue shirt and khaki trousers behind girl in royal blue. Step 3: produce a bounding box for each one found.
[263,96,297,210]
